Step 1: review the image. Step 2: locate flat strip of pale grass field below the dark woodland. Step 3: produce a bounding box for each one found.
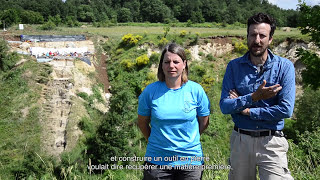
[3,23,307,39]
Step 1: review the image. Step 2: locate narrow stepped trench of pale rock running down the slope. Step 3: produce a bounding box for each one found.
[42,61,74,156]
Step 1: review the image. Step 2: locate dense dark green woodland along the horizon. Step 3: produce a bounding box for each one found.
[0,0,298,27]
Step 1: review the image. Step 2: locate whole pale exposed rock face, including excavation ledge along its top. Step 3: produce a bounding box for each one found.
[8,35,111,159]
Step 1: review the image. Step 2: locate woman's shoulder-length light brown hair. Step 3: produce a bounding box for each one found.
[158,43,188,85]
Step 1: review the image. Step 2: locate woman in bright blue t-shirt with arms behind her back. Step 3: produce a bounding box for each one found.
[138,43,210,180]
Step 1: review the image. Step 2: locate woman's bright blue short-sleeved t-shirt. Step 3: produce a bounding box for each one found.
[138,80,210,166]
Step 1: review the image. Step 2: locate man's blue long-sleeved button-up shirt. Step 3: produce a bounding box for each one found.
[220,50,295,130]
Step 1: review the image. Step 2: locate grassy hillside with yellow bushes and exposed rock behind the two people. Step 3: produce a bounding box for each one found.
[0,31,317,179]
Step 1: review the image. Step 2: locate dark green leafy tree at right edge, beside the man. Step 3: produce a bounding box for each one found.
[296,3,320,143]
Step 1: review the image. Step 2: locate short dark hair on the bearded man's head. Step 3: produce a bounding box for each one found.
[247,13,276,39]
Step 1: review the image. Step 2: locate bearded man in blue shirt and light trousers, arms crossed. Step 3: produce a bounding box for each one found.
[220,13,295,180]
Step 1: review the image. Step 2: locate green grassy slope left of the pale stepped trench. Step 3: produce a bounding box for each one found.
[0,57,53,179]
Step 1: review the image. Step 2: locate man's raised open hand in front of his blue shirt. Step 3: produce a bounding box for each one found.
[251,80,282,102]
